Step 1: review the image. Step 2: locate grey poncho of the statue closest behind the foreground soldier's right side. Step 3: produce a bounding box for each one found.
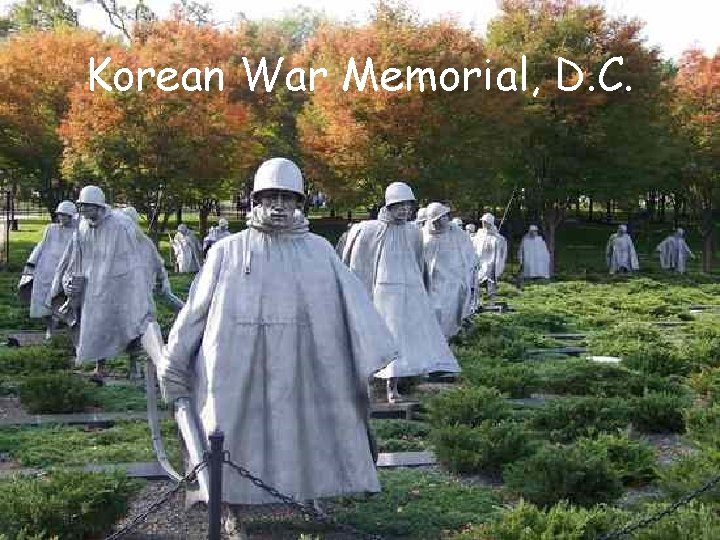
[343,207,460,378]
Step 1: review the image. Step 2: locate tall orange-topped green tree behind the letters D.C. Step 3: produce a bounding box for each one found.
[488,0,663,270]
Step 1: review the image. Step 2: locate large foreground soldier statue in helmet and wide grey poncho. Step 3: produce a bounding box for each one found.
[160,158,396,504]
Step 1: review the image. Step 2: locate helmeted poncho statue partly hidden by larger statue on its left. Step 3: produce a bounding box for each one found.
[423,202,477,338]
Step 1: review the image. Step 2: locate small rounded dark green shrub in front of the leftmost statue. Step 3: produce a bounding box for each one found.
[19,372,97,414]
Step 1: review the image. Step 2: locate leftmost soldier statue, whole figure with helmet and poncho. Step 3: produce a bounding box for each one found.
[18,201,77,339]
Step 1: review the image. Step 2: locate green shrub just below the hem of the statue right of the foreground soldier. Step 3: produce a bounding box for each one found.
[428,386,512,428]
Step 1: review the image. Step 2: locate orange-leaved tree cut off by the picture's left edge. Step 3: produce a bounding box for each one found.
[0,27,112,212]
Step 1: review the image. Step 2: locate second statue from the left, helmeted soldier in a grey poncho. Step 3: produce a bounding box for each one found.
[49,186,154,384]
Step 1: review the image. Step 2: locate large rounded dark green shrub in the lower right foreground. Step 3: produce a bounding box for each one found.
[503,444,623,507]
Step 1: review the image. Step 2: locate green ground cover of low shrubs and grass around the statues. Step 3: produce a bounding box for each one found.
[0,217,720,540]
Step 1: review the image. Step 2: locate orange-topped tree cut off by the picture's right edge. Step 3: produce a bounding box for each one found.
[675,49,720,272]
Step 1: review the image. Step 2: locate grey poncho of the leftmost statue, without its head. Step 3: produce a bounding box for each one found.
[27,221,76,319]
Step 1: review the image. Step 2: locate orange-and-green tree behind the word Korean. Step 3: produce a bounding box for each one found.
[61,20,259,232]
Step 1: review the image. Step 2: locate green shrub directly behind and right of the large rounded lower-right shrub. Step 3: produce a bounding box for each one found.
[575,434,657,487]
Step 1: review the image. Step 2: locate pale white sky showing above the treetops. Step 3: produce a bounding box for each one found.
[0,0,720,59]
